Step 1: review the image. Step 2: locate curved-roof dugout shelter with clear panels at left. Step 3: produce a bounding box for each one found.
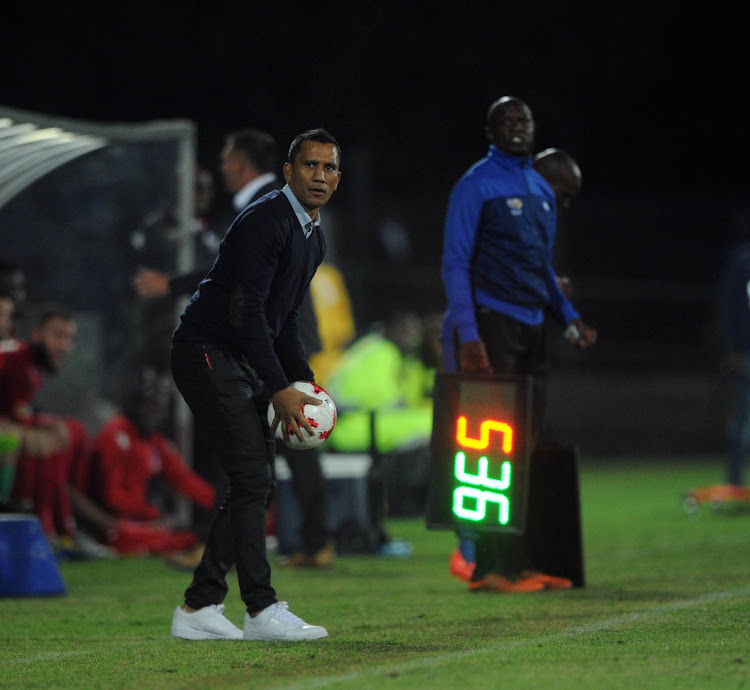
[0,106,196,468]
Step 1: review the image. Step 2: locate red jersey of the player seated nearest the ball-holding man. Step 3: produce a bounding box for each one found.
[91,415,214,520]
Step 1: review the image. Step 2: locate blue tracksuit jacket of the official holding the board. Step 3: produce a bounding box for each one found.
[441,146,580,350]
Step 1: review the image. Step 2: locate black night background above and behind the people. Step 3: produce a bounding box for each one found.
[0,2,750,354]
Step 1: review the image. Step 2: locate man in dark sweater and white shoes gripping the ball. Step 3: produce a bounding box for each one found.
[171,129,341,641]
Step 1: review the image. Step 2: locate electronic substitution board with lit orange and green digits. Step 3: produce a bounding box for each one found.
[426,374,532,534]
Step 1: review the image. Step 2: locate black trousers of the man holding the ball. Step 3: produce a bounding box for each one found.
[171,342,277,613]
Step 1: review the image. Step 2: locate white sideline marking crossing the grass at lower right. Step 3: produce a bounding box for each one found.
[284,587,750,690]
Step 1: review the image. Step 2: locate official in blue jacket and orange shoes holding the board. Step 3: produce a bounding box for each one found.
[441,96,596,592]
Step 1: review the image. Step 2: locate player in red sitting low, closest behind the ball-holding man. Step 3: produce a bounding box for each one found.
[71,365,214,555]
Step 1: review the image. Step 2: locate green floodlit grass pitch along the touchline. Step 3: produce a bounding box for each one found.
[0,458,750,690]
